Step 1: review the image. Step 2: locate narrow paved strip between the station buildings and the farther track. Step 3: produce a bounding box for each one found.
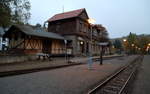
[0,55,120,77]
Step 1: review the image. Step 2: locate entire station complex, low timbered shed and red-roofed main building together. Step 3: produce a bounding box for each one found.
[4,8,108,56]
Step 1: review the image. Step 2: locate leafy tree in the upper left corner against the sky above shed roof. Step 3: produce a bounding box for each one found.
[0,0,30,28]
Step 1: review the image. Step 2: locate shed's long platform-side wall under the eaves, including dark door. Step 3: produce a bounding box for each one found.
[25,39,65,54]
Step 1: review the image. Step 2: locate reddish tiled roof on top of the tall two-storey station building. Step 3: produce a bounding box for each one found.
[48,8,88,22]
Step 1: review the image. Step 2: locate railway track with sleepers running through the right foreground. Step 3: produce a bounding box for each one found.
[88,56,143,94]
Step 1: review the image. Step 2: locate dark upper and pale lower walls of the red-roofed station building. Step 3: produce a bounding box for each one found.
[48,18,89,56]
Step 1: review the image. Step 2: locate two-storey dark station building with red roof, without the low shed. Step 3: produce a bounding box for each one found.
[47,9,108,56]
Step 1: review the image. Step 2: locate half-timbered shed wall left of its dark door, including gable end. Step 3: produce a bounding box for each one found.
[9,32,42,54]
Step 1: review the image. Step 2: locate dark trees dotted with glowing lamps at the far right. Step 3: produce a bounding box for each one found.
[113,33,150,54]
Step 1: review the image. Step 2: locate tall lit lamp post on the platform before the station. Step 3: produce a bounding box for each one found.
[88,18,95,69]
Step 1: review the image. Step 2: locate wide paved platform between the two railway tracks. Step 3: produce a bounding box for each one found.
[0,56,137,94]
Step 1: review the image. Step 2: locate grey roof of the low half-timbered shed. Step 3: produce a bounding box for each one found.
[4,25,64,40]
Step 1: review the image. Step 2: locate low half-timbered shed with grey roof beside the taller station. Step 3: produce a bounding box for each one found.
[4,25,65,54]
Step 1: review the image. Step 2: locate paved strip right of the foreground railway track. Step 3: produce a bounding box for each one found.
[132,55,150,94]
